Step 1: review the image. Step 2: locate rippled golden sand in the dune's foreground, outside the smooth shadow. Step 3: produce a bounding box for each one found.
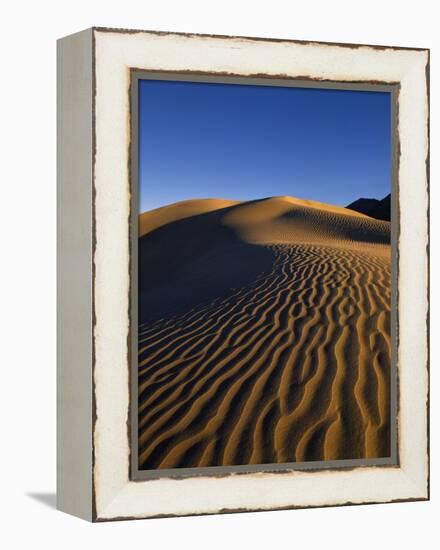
[139,242,391,469]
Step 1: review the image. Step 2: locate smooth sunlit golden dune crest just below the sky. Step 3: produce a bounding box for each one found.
[139,197,390,244]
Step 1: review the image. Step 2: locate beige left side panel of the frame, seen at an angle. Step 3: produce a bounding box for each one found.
[57,29,93,521]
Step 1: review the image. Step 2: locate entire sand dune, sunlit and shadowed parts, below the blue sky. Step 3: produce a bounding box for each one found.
[139,197,391,469]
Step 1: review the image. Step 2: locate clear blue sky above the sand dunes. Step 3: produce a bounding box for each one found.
[139,80,391,212]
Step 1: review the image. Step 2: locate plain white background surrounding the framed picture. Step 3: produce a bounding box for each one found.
[0,0,440,550]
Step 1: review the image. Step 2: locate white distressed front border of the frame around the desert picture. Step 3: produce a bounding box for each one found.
[63,29,429,520]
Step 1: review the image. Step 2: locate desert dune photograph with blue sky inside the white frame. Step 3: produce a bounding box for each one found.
[135,76,395,470]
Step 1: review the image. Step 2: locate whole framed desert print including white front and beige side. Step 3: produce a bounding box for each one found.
[57,28,429,521]
